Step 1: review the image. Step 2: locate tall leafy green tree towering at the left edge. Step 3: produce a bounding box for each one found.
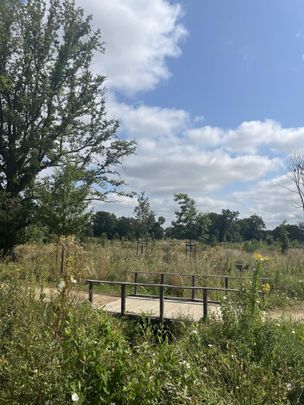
[0,0,134,252]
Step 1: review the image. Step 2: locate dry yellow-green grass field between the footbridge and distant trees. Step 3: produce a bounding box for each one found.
[13,241,304,307]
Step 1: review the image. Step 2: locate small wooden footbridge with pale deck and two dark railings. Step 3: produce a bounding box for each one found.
[87,271,268,321]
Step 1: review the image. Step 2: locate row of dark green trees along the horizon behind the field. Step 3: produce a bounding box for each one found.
[91,193,304,243]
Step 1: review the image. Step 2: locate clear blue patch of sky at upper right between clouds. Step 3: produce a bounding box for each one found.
[143,0,304,128]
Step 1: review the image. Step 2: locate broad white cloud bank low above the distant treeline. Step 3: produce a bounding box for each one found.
[99,99,304,227]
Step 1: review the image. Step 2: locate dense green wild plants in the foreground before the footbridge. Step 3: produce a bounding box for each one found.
[0,258,304,405]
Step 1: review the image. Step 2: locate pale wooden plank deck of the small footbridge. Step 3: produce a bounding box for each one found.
[102,297,221,321]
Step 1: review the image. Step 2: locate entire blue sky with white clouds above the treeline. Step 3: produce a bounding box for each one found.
[77,0,304,228]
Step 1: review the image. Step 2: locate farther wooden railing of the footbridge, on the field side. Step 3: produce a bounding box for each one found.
[130,271,269,301]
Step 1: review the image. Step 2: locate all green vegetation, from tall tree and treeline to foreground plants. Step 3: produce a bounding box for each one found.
[0,0,304,405]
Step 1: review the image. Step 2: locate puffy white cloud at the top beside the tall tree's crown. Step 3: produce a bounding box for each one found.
[77,0,187,95]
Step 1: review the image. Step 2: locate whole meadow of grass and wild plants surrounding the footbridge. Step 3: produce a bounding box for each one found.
[0,238,304,405]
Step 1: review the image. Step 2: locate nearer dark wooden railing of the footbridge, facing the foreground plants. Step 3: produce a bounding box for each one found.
[87,279,239,321]
